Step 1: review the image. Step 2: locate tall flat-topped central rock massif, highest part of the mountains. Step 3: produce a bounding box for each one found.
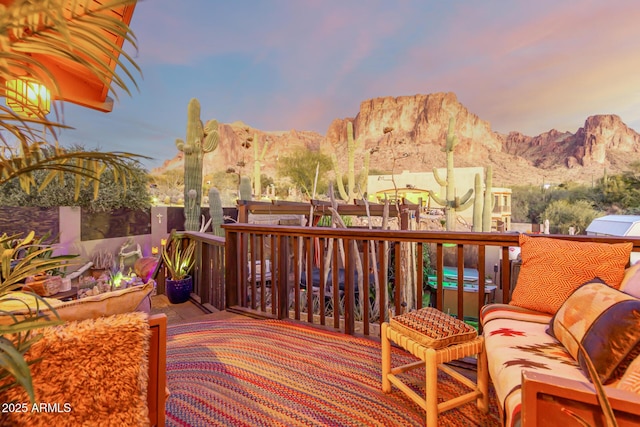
[323,93,503,181]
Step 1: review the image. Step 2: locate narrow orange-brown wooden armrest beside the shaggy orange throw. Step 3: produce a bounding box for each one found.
[147,314,167,426]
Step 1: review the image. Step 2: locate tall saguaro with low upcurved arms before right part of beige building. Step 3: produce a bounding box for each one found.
[429,117,473,230]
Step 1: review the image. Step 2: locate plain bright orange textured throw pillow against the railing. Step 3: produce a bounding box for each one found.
[509,234,633,314]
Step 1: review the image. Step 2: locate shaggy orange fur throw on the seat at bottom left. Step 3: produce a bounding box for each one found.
[0,313,151,427]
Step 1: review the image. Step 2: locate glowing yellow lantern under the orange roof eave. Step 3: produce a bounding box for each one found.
[5,77,51,117]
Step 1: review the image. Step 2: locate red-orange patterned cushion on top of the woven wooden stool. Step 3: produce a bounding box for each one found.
[389,307,478,348]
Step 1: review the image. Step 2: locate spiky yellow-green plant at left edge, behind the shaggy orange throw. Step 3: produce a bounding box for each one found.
[0,231,75,402]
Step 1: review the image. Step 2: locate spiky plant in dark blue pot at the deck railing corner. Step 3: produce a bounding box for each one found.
[162,236,196,304]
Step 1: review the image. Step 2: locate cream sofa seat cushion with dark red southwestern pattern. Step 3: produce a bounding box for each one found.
[481,304,586,426]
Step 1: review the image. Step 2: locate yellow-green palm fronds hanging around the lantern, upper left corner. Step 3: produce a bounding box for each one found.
[0,0,144,197]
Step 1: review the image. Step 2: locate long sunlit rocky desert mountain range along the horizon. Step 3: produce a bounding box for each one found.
[154,93,640,185]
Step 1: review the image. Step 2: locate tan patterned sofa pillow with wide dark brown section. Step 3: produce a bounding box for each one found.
[548,278,640,383]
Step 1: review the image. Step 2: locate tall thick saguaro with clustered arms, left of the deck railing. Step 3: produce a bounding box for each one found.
[176,98,219,231]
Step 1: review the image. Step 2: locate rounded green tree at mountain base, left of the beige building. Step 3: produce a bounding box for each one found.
[278,149,333,197]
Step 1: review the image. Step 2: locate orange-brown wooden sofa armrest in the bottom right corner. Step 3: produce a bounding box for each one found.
[522,371,640,427]
